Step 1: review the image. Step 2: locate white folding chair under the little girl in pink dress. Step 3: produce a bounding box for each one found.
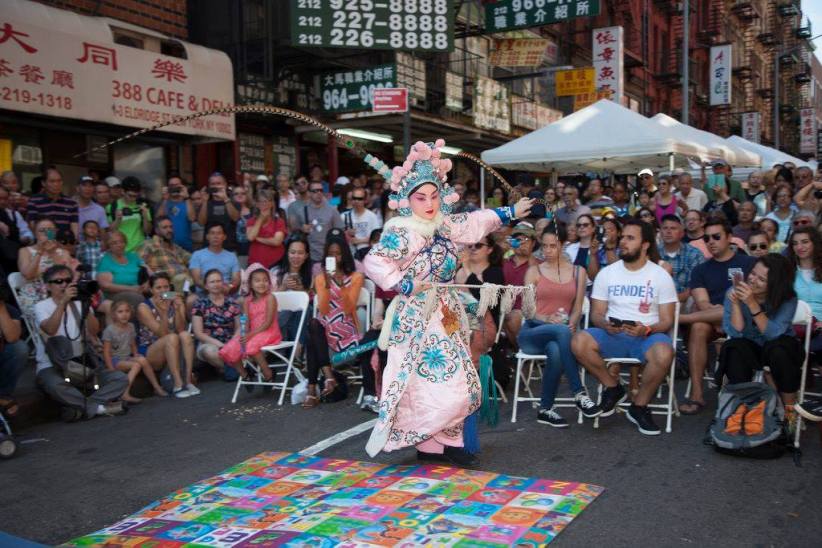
[231,291,309,405]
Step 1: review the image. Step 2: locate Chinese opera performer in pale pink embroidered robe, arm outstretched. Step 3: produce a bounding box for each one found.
[364,139,533,466]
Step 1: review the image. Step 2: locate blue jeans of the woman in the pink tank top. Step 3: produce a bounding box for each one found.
[517,320,583,409]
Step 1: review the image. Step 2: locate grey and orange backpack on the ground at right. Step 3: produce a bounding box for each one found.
[706,382,787,459]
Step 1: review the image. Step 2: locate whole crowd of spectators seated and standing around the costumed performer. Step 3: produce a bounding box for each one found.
[0,158,822,434]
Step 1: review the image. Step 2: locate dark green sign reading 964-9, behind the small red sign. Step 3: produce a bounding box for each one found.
[320,64,397,112]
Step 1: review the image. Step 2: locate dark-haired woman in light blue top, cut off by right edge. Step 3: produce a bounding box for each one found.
[788,226,822,352]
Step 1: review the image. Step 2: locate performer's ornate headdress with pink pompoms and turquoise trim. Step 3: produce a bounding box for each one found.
[365,139,459,217]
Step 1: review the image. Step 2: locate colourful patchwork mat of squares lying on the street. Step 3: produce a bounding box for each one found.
[68,453,603,548]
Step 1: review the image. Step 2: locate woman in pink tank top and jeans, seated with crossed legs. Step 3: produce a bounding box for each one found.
[517,225,597,428]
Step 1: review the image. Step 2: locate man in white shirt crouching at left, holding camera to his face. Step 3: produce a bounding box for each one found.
[34,265,128,422]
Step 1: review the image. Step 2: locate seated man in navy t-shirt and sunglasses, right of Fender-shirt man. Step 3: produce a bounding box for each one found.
[679,216,756,415]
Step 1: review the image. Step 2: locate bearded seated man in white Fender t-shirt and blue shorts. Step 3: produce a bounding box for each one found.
[571,220,677,436]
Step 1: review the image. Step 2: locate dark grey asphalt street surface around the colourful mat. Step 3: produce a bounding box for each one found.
[0,381,822,547]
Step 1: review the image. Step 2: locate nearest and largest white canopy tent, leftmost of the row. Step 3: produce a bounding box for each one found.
[482,99,711,173]
